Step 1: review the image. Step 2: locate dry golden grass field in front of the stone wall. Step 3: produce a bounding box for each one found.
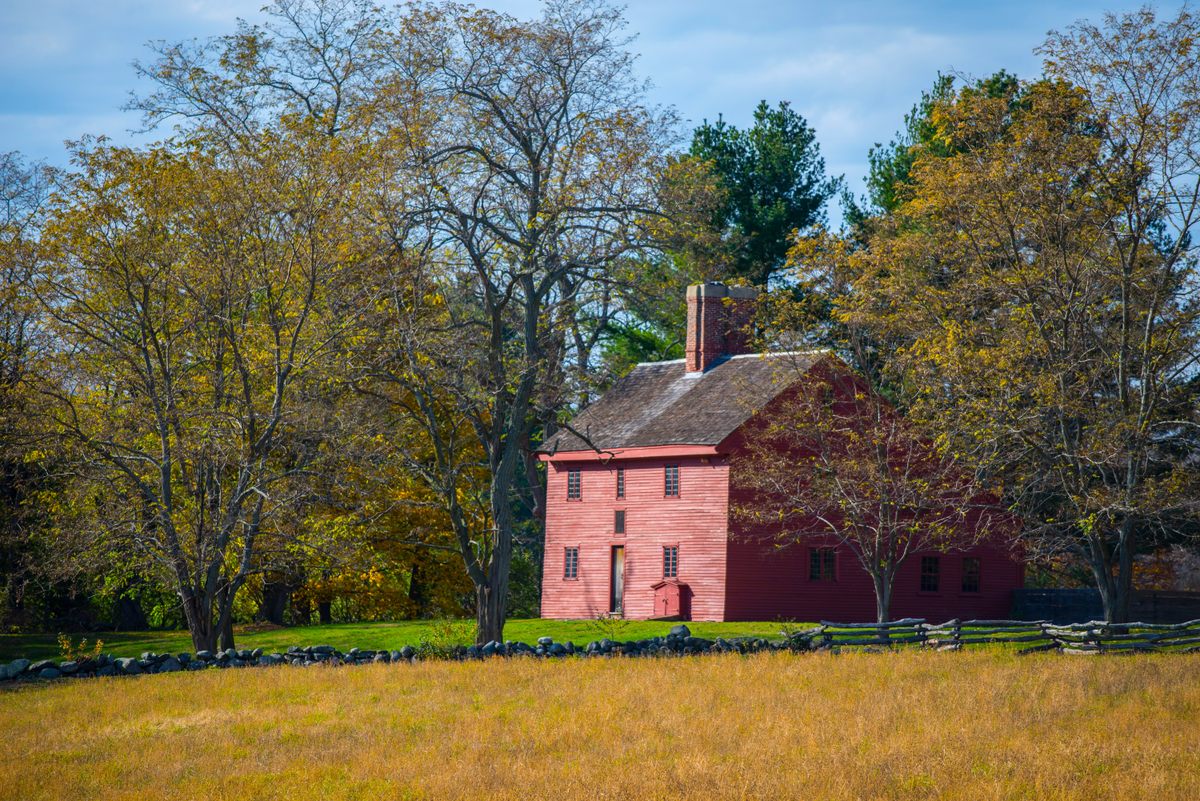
[0,651,1200,801]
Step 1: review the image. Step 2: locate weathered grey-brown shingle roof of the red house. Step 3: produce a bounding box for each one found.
[539,351,824,453]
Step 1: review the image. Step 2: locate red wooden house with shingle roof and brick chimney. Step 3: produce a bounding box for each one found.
[540,284,1024,621]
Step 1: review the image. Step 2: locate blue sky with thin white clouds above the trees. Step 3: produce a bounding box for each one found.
[0,0,1161,211]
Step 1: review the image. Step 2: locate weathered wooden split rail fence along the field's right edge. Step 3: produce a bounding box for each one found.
[788,618,1200,654]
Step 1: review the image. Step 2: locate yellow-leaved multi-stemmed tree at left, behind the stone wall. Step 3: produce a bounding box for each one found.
[40,128,364,649]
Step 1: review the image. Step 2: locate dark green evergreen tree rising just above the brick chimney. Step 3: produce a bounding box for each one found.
[691,101,840,285]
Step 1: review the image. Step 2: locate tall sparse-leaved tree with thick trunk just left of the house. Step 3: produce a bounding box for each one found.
[355,0,673,643]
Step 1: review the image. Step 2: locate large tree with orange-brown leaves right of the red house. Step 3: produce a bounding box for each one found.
[840,10,1200,621]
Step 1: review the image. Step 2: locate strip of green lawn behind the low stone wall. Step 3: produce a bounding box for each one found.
[0,619,801,662]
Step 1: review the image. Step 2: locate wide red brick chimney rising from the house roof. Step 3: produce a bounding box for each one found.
[688,283,758,373]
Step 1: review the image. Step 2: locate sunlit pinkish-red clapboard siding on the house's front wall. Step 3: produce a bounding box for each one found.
[541,454,728,620]
